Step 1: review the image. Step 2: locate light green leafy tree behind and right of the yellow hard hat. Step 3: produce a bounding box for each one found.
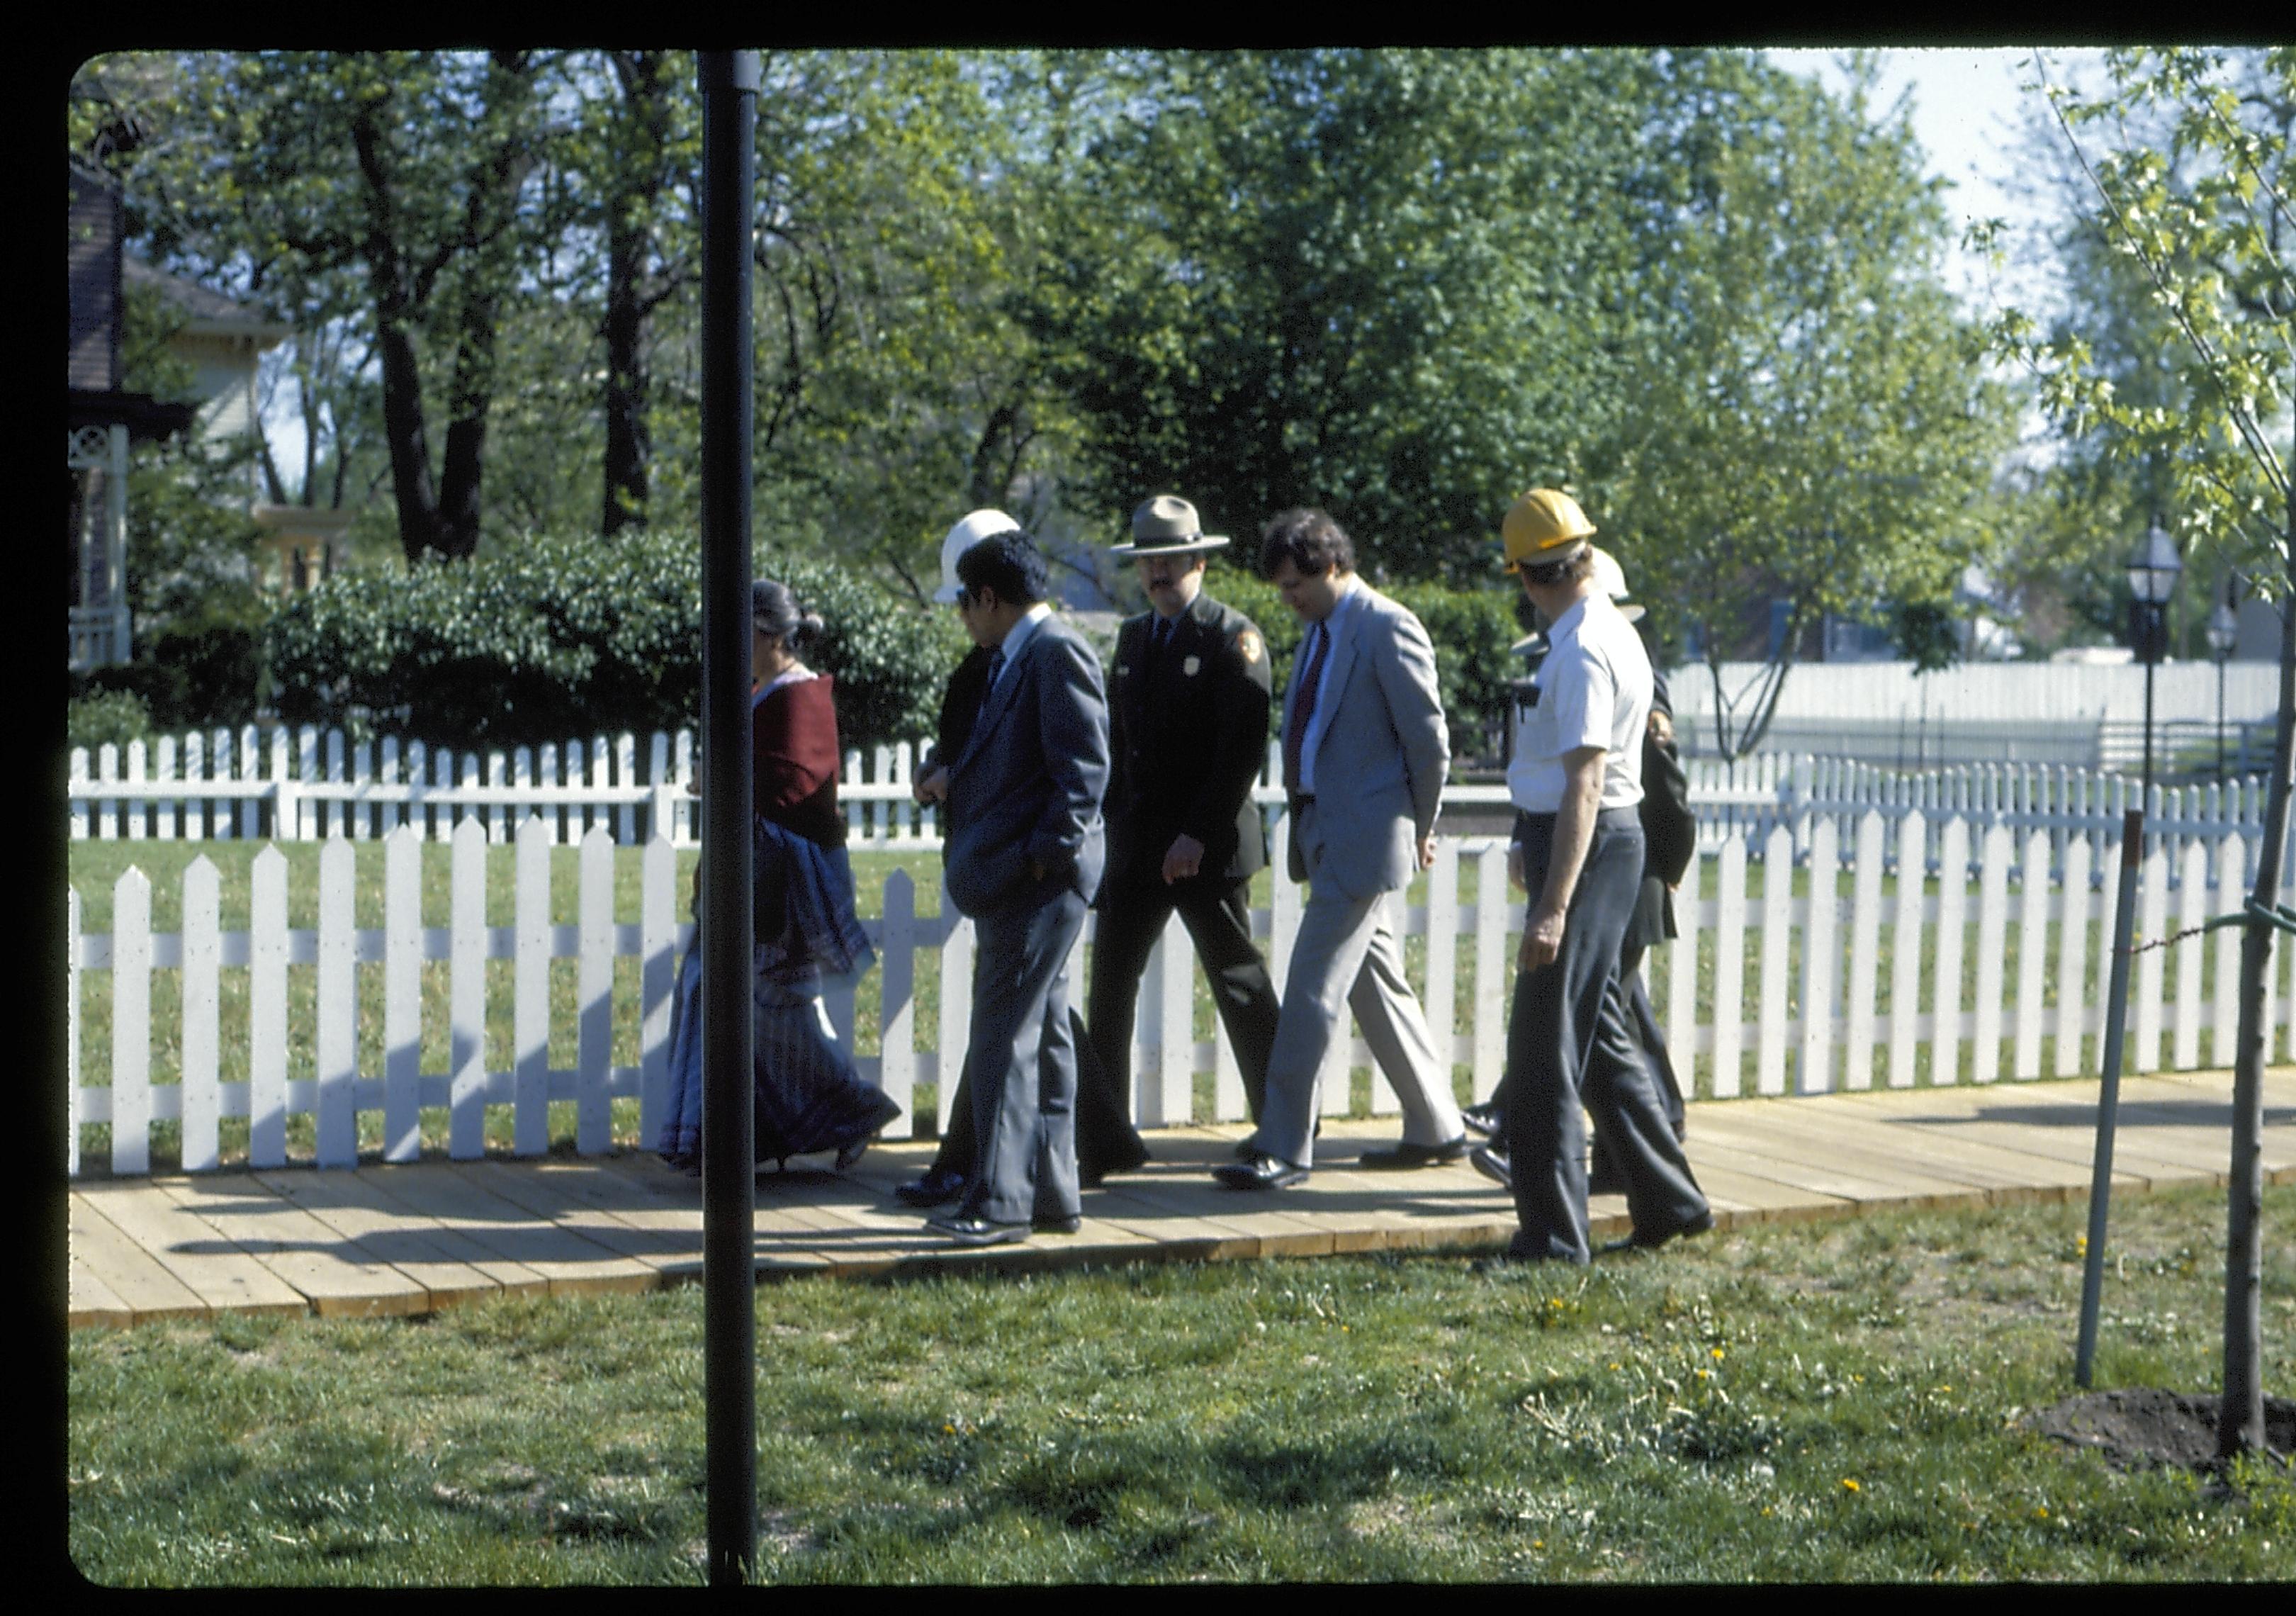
[1587,50,2009,758]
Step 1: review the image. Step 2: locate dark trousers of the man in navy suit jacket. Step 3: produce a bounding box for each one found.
[957,886,1084,1223]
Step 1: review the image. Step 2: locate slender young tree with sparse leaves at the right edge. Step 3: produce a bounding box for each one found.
[1993,48,2296,1458]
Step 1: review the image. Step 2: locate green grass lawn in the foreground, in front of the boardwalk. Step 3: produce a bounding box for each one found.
[69,1186,2296,1586]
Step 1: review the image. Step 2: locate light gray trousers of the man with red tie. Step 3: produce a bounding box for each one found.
[1251,804,1465,1166]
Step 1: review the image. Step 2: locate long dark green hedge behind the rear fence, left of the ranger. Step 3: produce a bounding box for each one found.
[264,532,964,748]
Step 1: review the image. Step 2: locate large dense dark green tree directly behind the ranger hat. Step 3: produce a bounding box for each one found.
[1024,50,1623,576]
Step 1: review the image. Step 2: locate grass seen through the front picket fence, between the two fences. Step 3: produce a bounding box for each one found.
[69,843,2268,1168]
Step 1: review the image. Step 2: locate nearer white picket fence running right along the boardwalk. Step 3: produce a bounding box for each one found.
[67,808,2296,1173]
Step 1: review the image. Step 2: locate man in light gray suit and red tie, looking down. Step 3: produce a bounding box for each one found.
[1215,510,1467,1189]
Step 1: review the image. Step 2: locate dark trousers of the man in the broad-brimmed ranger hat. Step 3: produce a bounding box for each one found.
[1077,877,1281,1171]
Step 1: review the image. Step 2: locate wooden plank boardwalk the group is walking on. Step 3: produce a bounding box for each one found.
[69,1067,2296,1327]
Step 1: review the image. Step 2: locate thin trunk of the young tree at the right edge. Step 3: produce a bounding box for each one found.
[2216,445,2296,1460]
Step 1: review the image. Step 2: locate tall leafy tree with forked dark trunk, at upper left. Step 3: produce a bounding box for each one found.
[99,50,565,560]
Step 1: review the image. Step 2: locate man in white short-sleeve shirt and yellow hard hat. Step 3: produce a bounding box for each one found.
[1476,489,1713,1262]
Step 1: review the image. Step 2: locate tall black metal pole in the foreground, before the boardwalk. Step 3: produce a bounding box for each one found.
[700,50,758,1586]
